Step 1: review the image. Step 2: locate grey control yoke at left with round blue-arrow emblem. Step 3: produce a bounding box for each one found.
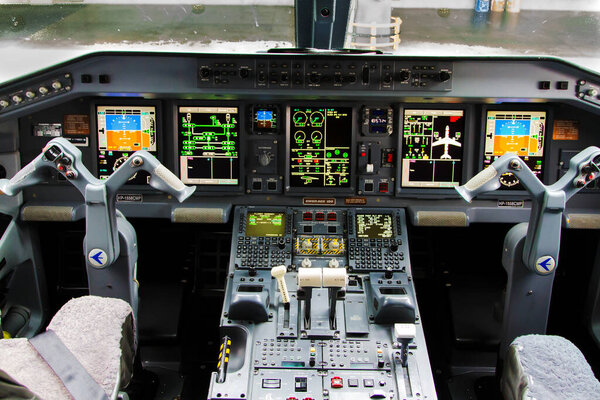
[0,138,196,268]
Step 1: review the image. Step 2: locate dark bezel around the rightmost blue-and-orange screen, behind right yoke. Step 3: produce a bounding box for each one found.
[472,103,554,193]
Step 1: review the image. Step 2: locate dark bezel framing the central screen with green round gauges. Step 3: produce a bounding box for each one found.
[284,101,358,195]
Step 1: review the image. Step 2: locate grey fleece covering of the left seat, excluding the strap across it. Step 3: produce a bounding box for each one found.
[0,296,136,400]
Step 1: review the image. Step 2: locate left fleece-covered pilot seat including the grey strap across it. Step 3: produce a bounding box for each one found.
[0,296,137,400]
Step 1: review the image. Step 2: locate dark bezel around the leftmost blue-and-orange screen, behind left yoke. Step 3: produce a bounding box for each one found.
[90,97,163,190]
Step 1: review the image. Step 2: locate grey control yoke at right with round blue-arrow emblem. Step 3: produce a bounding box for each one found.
[456,146,600,275]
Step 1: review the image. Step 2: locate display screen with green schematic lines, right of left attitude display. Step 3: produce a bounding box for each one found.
[177,106,240,185]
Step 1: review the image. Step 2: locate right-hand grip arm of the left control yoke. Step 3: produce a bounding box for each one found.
[106,150,196,203]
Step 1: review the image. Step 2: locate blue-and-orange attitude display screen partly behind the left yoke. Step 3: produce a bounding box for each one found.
[96,106,157,184]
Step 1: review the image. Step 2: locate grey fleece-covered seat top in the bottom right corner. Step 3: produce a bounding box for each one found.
[502,335,600,400]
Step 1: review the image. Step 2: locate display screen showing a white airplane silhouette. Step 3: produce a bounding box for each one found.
[402,110,465,188]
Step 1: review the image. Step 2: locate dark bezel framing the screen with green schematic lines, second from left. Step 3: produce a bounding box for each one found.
[172,101,246,195]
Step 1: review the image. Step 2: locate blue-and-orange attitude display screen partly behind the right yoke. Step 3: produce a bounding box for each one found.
[483,111,546,190]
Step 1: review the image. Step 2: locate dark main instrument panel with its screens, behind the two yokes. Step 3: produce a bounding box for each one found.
[0,53,600,226]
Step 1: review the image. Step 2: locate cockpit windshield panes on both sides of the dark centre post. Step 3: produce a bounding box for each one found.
[0,0,600,82]
